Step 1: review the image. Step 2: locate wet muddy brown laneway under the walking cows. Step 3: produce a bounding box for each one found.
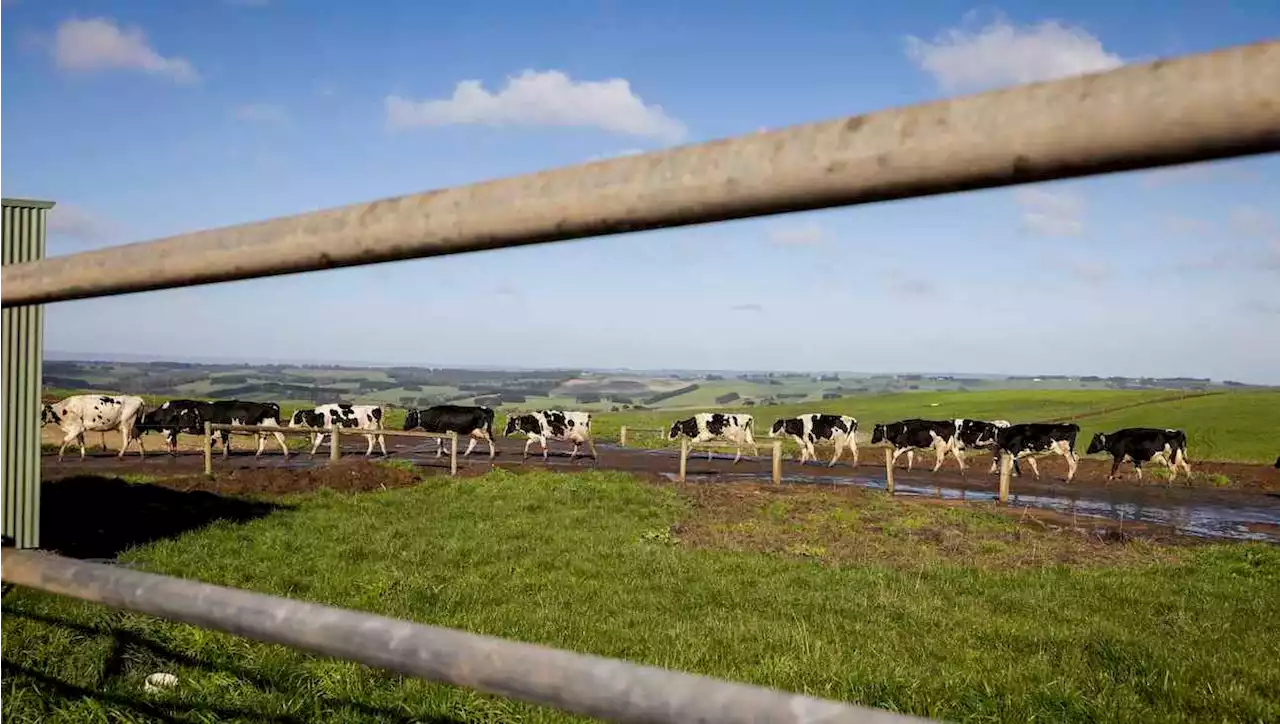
[42,436,1280,542]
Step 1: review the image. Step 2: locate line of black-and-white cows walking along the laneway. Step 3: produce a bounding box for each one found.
[41,394,1239,482]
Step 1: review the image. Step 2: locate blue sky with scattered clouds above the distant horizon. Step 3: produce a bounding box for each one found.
[0,0,1280,382]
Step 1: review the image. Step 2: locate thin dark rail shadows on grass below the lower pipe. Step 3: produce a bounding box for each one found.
[0,606,462,724]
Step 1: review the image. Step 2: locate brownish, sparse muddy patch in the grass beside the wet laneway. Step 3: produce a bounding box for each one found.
[675,482,1203,569]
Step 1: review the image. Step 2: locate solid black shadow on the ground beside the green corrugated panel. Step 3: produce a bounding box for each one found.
[40,475,292,559]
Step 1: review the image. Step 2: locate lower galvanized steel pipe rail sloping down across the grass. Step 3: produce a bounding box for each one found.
[0,549,929,724]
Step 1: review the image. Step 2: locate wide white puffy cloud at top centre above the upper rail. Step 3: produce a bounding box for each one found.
[385,70,686,142]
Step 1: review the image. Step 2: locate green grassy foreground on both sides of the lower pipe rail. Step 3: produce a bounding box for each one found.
[0,471,1280,721]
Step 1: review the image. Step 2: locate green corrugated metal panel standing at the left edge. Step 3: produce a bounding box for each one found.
[0,198,54,547]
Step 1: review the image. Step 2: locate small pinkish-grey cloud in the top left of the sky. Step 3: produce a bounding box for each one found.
[52,18,200,83]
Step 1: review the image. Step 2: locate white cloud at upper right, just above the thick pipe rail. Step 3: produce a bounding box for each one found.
[906,13,1124,92]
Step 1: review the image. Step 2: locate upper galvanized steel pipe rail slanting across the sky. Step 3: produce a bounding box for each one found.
[0,41,1280,306]
